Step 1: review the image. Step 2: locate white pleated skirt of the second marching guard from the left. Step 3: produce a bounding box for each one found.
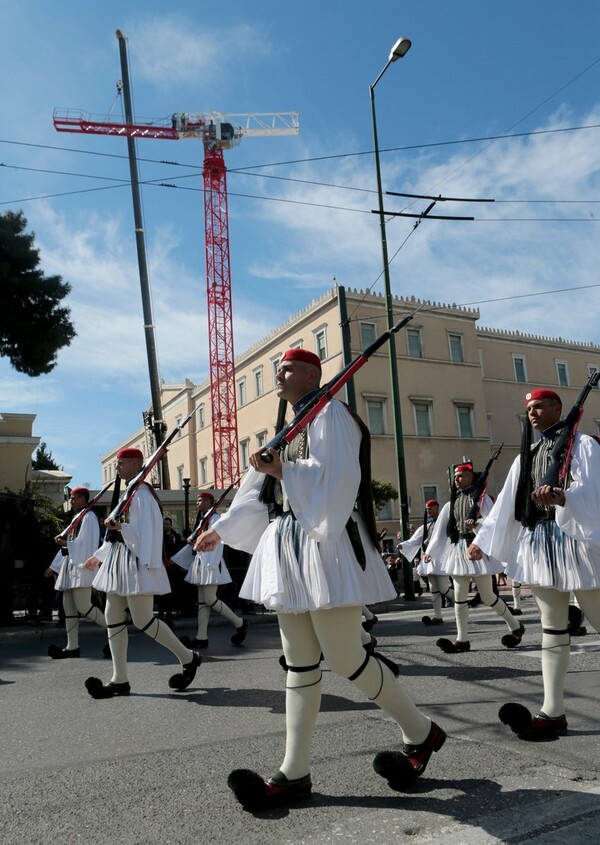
[92,543,171,596]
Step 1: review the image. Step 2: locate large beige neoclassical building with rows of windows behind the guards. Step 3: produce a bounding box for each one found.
[102,286,600,537]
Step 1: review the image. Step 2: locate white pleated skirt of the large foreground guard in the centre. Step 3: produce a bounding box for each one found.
[240,514,396,613]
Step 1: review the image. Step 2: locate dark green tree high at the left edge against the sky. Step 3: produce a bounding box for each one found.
[0,211,76,376]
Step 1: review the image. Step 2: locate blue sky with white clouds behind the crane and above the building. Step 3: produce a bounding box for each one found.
[0,0,600,486]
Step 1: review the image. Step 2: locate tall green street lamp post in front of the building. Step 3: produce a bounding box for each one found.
[369,38,414,552]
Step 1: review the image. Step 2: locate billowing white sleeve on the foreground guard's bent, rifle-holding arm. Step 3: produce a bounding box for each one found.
[282,399,361,542]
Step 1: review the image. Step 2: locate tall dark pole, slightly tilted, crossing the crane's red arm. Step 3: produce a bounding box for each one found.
[116,29,171,490]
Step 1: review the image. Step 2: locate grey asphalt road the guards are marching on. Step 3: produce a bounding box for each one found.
[0,599,600,845]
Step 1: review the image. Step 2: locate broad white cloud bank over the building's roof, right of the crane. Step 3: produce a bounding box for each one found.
[246,110,600,342]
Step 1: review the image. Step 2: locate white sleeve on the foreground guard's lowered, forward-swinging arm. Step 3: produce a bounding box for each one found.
[211,468,269,554]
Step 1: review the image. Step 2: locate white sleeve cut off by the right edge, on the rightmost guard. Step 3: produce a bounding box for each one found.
[556,434,600,544]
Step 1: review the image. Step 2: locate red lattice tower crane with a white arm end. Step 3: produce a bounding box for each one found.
[53,78,300,489]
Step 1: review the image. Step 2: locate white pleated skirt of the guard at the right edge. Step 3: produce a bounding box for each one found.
[506,520,600,593]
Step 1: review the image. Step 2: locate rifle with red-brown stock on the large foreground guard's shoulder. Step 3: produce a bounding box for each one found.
[260,303,425,464]
